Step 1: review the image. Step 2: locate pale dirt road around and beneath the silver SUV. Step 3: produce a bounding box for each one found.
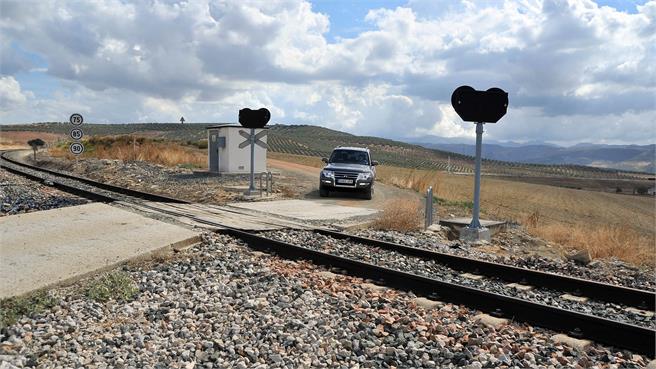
[267,158,421,209]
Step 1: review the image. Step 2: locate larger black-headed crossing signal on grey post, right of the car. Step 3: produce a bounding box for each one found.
[451,86,508,242]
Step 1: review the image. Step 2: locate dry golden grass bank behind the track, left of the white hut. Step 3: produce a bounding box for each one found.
[51,136,207,168]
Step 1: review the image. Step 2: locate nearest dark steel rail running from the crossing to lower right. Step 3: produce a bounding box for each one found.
[218,229,656,357]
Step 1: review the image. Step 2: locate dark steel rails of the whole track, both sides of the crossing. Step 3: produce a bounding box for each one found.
[0,153,656,358]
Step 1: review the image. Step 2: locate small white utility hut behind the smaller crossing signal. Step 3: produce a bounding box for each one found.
[207,124,267,174]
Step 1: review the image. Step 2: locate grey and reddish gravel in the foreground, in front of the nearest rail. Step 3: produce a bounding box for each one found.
[0,235,647,368]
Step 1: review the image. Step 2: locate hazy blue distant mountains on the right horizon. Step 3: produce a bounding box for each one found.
[415,142,656,173]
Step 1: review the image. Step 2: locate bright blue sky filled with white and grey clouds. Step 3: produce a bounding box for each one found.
[0,0,656,145]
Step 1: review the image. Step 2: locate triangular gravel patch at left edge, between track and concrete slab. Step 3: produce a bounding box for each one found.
[0,169,89,216]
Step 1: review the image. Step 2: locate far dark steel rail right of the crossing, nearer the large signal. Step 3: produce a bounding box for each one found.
[314,229,656,311]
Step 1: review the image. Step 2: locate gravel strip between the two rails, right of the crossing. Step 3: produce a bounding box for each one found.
[263,230,656,328]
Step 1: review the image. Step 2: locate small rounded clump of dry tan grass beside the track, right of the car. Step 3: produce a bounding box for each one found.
[371,199,423,232]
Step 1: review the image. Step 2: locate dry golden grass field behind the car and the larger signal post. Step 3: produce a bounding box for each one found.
[270,154,656,266]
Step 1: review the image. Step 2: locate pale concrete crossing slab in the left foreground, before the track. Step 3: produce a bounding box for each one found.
[0,203,200,298]
